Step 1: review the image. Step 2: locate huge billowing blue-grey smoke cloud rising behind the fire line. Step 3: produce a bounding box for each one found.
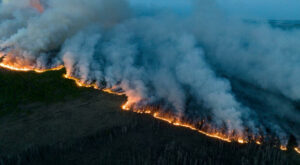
[0,0,300,143]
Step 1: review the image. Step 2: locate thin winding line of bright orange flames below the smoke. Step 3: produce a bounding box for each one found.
[0,63,300,154]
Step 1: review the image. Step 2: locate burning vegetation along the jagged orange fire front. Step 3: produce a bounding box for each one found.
[0,63,300,154]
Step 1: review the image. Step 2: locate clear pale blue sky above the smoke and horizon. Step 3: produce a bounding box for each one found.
[130,0,300,20]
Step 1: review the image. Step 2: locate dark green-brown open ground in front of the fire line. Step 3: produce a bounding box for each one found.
[0,69,300,165]
